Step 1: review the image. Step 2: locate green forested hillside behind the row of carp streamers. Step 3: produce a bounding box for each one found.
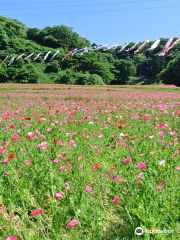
[0,16,180,86]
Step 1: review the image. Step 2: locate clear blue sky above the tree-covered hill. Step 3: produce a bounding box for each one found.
[0,0,180,47]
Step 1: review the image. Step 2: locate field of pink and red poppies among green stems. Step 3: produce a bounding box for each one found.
[0,84,180,240]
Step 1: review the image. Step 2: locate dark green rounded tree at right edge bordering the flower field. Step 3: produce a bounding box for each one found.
[158,56,180,87]
